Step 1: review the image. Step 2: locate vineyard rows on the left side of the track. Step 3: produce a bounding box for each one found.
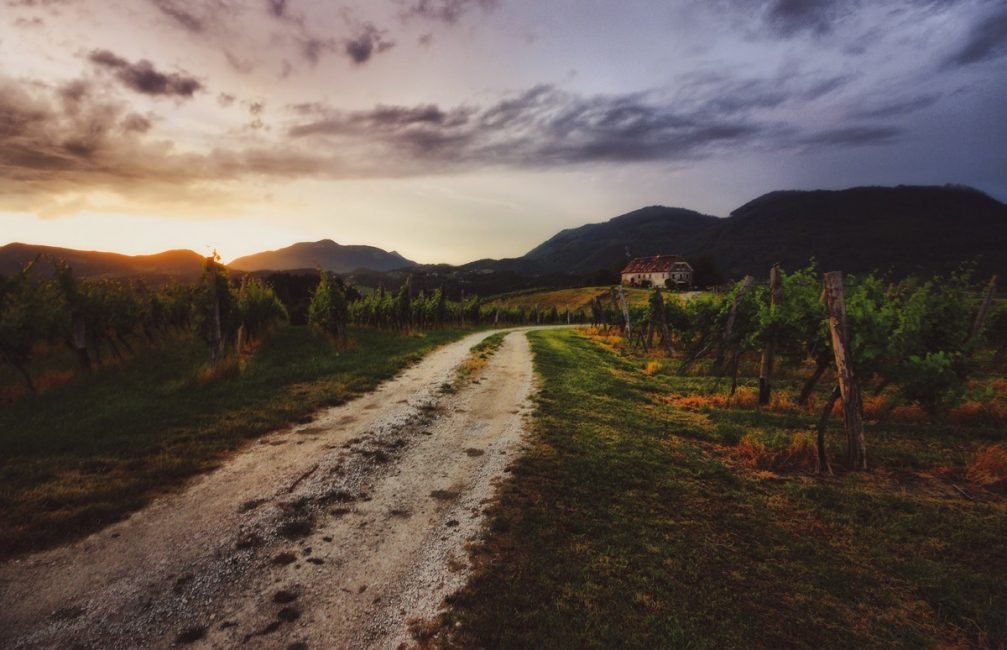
[0,257,588,396]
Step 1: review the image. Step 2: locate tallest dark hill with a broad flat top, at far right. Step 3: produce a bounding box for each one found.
[698,186,1007,276]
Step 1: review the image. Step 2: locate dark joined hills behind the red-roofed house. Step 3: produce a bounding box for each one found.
[493,186,1007,277]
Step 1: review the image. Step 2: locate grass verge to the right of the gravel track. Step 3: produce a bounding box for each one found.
[423,331,1007,648]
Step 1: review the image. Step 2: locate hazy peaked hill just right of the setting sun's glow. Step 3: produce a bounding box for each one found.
[228,239,416,273]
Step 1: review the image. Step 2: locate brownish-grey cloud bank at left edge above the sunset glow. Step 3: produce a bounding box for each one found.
[0,76,339,210]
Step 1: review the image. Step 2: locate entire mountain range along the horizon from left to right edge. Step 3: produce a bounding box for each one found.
[0,185,1007,288]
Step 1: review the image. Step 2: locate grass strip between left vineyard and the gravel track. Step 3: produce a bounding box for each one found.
[0,327,470,557]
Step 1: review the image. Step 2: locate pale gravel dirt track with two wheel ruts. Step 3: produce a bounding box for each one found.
[0,332,559,648]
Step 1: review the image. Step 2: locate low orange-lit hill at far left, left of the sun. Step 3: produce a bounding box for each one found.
[0,243,203,278]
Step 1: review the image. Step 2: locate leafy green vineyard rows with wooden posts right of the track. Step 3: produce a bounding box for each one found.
[591,265,1007,470]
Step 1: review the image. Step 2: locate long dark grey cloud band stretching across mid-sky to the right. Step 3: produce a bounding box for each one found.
[287,80,903,172]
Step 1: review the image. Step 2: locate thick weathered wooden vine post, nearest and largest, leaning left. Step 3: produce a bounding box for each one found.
[825,271,867,470]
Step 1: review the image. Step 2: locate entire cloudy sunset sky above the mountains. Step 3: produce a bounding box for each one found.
[0,0,1007,263]
